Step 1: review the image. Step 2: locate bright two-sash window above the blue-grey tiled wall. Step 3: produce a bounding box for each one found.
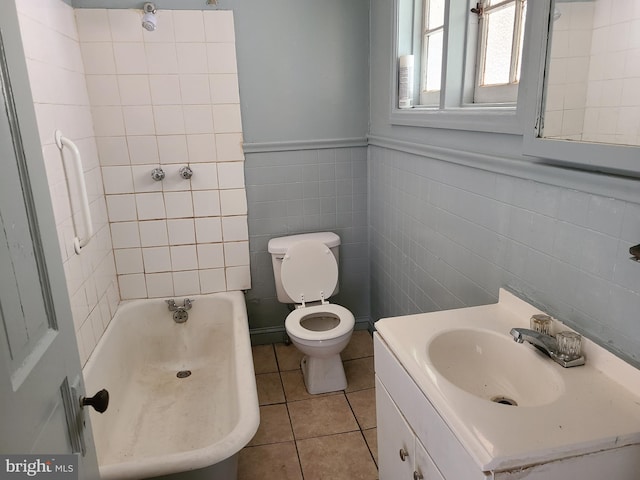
[412,0,527,109]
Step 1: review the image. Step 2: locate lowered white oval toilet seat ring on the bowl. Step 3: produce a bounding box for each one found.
[284,303,356,341]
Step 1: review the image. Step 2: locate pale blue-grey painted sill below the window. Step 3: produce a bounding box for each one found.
[389,106,523,135]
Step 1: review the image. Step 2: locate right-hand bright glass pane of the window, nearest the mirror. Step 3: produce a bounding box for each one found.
[482,4,515,85]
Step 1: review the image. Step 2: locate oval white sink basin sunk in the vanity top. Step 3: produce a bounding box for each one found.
[427,328,564,407]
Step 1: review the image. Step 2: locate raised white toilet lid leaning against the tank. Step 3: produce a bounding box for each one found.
[280,240,338,303]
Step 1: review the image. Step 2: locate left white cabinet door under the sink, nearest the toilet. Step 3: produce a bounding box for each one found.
[376,377,415,480]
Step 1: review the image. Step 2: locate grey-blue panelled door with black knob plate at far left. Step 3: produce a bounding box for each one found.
[0,1,99,479]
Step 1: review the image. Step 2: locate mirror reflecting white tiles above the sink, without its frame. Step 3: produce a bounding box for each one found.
[541,0,640,146]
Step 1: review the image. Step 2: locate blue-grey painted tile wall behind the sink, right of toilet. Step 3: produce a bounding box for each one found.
[369,146,640,365]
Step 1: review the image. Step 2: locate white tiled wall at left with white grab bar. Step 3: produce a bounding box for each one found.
[16,0,120,364]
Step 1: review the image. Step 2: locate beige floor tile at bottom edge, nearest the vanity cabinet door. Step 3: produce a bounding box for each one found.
[296,432,378,480]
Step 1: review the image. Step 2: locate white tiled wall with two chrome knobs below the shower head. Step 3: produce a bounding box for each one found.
[76,9,251,299]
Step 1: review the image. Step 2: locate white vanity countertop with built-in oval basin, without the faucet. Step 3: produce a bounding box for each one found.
[376,290,640,471]
